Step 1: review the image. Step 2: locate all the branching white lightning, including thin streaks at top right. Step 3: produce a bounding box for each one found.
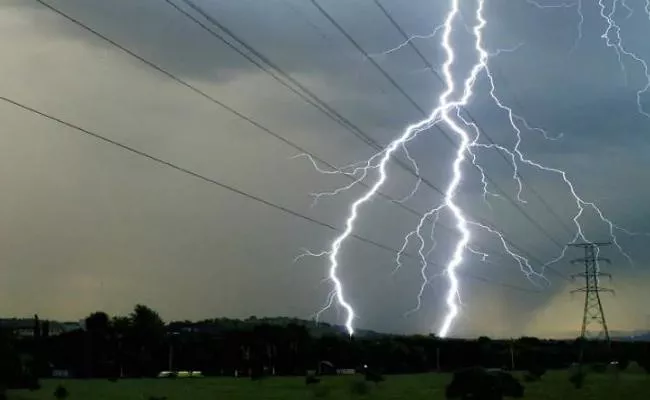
[306,0,636,337]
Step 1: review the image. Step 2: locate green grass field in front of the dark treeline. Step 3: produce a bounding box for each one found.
[9,372,650,400]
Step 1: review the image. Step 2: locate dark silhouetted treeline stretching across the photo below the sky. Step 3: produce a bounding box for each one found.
[0,305,650,387]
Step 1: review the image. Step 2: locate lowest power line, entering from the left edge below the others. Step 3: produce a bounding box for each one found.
[0,96,539,293]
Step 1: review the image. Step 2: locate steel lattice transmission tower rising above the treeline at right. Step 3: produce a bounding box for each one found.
[569,242,614,343]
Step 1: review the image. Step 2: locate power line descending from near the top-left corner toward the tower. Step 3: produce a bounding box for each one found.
[36,0,568,280]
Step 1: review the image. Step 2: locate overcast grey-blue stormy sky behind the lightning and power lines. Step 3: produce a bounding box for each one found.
[0,0,650,336]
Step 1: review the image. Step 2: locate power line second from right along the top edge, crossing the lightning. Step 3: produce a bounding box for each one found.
[310,0,564,248]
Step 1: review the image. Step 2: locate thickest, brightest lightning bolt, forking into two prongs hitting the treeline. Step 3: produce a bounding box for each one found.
[312,0,547,337]
